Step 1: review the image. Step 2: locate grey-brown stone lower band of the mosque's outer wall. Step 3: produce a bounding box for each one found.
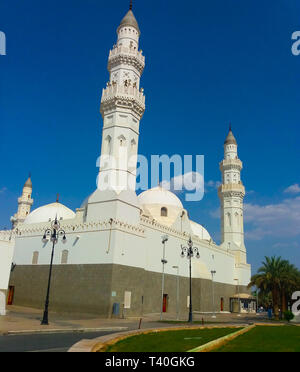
[10,264,249,317]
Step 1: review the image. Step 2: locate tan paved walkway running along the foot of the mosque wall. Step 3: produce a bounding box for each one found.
[0,306,266,334]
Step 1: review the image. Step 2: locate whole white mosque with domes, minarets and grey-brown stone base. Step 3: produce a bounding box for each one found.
[0,7,254,317]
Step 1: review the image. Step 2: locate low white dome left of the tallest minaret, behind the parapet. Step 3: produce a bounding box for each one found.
[24,203,76,224]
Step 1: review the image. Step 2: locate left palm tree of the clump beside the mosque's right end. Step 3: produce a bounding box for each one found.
[248,256,288,319]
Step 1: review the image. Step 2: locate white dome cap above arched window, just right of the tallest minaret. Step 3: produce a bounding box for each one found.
[138,186,183,209]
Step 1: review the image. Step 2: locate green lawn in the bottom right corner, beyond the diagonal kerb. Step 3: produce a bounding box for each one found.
[214,326,300,352]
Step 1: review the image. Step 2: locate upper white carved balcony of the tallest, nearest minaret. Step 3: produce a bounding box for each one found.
[107,46,145,74]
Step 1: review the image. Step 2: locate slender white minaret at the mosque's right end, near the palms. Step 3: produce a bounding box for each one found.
[218,125,246,263]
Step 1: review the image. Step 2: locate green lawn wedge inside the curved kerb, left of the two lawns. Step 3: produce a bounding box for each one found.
[107,328,241,352]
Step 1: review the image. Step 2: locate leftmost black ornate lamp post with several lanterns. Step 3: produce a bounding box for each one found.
[41,217,67,325]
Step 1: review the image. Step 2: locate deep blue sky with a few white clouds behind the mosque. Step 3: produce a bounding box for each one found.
[0,0,300,271]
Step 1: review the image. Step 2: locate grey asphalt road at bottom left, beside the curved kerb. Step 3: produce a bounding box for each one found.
[0,331,118,353]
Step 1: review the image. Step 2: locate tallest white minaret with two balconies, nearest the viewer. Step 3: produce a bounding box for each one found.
[98,2,145,193]
